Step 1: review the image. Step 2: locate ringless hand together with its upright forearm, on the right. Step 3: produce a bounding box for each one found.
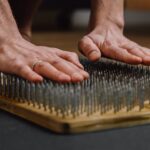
[78,0,150,65]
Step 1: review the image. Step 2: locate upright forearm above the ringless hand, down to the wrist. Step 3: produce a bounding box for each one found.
[90,0,124,28]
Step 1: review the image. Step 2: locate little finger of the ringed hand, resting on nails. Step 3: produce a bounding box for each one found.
[16,66,43,82]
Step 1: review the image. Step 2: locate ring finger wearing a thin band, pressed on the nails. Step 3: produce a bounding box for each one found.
[34,62,71,82]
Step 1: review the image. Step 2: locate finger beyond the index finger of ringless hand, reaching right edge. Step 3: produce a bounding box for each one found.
[122,45,150,65]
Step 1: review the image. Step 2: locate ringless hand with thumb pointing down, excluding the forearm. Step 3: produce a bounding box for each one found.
[79,23,150,65]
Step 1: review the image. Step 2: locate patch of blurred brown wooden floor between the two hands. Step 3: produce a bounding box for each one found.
[33,32,83,52]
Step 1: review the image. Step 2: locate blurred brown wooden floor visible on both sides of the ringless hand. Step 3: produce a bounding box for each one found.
[33,31,150,52]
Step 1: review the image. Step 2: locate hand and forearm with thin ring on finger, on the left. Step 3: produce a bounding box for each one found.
[0,0,89,82]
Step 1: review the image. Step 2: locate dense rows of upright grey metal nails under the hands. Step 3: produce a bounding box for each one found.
[0,59,150,117]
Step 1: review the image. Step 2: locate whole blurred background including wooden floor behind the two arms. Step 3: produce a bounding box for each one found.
[28,0,150,53]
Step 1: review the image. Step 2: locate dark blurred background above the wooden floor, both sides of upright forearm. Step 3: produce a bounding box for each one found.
[34,0,150,30]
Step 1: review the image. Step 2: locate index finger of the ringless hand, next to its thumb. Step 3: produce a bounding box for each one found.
[102,45,142,64]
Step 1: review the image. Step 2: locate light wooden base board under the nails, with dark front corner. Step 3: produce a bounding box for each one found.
[0,97,150,133]
